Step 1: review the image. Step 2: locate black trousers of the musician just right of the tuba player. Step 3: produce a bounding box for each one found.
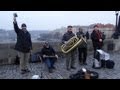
[78,48,87,63]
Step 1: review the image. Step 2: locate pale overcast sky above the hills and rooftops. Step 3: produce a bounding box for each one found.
[0,11,115,30]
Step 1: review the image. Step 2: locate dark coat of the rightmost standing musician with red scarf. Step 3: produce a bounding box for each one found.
[91,30,103,49]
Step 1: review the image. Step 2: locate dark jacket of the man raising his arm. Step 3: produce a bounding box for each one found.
[13,22,32,53]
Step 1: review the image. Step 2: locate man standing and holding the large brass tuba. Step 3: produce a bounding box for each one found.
[62,26,76,71]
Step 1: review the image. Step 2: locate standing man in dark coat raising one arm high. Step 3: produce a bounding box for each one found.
[13,13,32,74]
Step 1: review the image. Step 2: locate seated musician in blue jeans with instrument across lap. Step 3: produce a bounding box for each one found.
[41,42,58,73]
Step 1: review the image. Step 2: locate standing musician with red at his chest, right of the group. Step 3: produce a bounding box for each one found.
[91,25,103,58]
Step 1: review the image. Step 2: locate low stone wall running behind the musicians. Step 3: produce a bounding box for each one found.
[0,39,120,65]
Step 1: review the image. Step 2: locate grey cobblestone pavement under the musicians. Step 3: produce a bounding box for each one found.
[0,52,120,79]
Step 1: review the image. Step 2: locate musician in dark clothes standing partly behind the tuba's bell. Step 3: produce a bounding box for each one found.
[76,28,87,65]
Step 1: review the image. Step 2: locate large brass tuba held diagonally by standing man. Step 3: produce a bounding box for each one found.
[61,36,87,53]
